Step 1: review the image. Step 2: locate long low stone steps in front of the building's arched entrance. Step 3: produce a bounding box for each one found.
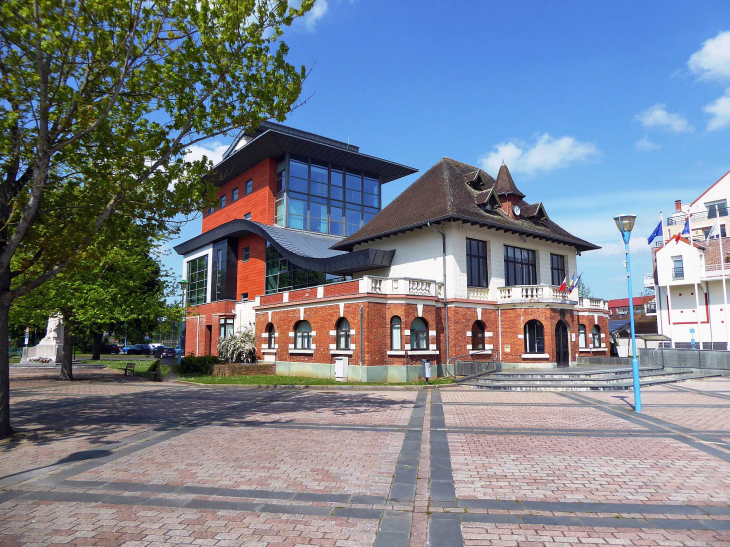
[461,371,722,391]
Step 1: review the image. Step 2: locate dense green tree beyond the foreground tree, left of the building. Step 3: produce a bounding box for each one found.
[10,223,173,380]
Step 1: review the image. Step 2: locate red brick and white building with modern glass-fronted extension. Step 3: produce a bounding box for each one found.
[176,124,608,381]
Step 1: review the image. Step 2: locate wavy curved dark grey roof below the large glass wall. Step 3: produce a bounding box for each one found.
[175,219,395,274]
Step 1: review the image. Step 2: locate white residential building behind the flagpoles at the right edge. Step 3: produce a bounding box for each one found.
[644,172,730,349]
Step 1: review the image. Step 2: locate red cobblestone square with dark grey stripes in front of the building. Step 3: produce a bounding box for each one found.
[0,369,730,547]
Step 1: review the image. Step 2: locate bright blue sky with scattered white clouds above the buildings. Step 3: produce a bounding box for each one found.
[165,0,730,299]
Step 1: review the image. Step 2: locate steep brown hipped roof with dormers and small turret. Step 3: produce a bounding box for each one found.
[332,158,600,252]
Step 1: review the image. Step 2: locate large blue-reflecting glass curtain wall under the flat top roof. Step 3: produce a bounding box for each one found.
[275,156,380,236]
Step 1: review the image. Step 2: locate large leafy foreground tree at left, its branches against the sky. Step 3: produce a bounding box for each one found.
[0,0,314,438]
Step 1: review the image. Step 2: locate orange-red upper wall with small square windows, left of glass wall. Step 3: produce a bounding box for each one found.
[203,158,276,233]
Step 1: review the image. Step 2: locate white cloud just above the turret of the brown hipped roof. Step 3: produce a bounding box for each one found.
[479,133,600,175]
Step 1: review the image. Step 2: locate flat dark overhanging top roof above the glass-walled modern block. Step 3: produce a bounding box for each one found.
[206,122,418,186]
